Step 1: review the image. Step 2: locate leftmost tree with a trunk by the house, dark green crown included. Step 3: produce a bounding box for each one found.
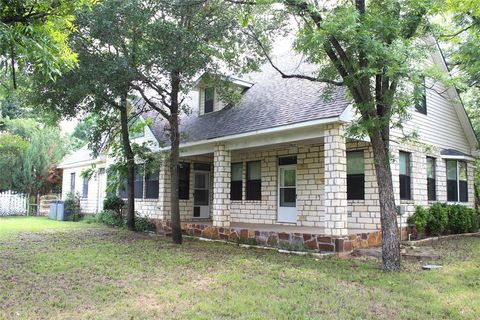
[33,0,158,230]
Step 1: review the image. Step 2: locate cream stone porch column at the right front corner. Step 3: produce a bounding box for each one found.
[324,124,348,236]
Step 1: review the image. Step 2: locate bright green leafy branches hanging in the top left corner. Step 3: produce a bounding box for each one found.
[0,0,92,89]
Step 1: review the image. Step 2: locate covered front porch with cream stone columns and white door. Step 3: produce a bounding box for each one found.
[167,123,370,236]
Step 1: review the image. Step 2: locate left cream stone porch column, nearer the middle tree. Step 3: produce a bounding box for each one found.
[212,144,231,227]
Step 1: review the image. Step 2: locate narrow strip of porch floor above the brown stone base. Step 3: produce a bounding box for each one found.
[182,220,368,234]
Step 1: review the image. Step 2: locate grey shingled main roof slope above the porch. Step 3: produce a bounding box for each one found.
[145,54,349,144]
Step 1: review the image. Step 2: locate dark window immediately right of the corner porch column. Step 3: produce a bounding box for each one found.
[347,151,365,200]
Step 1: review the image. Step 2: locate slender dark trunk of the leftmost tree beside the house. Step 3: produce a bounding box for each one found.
[120,95,135,231]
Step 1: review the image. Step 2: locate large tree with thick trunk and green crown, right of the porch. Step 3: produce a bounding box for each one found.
[249,0,430,271]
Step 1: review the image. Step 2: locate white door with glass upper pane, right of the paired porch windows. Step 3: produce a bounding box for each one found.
[278,164,297,223]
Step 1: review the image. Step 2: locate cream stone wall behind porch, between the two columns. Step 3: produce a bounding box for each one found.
[230,143,324,228]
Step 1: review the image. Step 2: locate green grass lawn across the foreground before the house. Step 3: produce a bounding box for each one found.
[0,218,480,319]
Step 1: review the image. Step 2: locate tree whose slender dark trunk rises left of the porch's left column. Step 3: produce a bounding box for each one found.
[126,0,277,243]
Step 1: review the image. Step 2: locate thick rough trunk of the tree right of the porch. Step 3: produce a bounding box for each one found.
[370,130,400,271]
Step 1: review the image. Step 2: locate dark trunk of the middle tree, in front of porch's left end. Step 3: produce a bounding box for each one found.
[169,74,182,244]
